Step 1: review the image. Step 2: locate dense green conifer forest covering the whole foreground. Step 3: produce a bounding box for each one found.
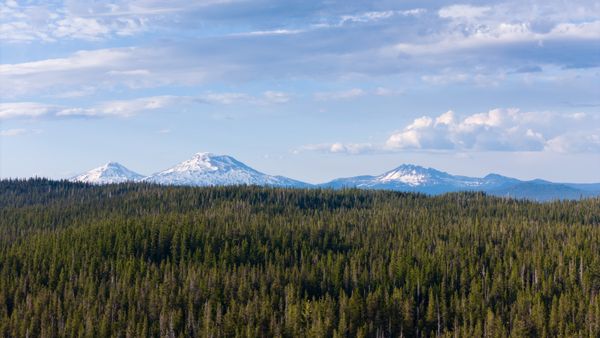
[0,179,600,337]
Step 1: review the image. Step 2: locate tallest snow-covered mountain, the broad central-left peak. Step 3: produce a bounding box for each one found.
[143,153,311,188]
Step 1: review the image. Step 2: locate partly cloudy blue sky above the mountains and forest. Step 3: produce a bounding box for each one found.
[0,0,600,183]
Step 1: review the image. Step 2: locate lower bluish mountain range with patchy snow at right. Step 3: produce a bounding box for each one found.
[320,164,600,201]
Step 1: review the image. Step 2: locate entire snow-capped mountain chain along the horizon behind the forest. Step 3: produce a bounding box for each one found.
[71,152,600,201]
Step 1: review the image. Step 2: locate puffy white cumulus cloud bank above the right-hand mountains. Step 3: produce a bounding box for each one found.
[384,109,597,151]
